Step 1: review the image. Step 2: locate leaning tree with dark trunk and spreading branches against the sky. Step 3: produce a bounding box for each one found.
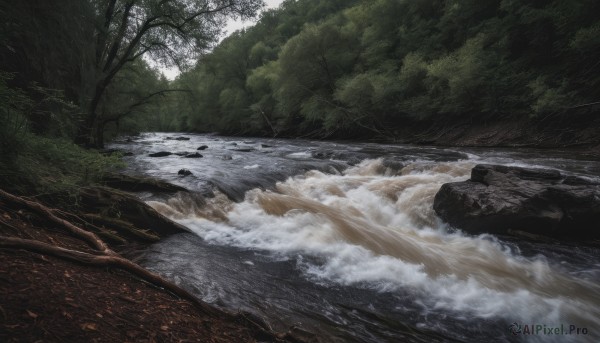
[76,0,263,146]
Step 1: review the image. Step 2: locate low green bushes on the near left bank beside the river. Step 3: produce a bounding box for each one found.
[0,73,121,195]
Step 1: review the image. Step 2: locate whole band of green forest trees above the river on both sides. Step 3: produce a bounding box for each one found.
[0,0,600,150]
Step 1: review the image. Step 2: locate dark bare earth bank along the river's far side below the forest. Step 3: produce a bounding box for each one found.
[217,110,600,160]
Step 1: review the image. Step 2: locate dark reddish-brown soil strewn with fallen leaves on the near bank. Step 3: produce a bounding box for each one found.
[0,202,290,342]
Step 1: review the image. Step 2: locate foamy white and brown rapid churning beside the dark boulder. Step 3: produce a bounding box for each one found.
[150,160,600,341]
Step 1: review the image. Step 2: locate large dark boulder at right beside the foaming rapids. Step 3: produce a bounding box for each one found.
[433,165,600,237]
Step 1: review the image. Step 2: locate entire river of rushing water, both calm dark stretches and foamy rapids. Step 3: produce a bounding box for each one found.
[113,134,600,342]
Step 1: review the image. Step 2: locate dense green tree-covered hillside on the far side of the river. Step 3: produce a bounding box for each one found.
[172,0,600,137]
